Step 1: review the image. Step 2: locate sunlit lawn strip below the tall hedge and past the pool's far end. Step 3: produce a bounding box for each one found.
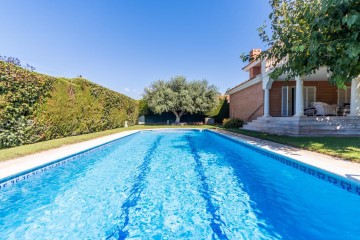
[0,125,214,161]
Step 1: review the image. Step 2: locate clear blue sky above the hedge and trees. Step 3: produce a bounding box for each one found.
[0,0,270,99]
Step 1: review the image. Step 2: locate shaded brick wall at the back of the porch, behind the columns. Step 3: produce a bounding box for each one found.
[270,81,338,117]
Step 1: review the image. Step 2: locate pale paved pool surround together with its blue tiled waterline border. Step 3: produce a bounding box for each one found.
[0,128,360,195]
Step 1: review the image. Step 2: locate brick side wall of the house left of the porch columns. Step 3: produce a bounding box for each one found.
[230,82,264,121]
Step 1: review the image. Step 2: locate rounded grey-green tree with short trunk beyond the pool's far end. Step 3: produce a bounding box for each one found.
[144,76,219,123]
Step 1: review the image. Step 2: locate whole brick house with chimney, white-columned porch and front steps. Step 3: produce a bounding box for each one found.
[227,49,360,136]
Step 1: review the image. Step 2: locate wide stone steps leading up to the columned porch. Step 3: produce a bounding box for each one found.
[243,116,360,136]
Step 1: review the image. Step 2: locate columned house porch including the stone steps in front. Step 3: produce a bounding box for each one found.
[244,61,360,136]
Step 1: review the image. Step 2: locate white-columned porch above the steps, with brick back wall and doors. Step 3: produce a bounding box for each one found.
[262,65,360,117]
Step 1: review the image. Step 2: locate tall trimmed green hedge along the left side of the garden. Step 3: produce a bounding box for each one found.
[0,61,138,148]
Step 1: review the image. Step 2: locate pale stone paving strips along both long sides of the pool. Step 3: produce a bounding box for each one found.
[0,129,360,184]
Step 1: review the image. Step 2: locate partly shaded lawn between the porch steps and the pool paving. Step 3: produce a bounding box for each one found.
[222,128,360,163]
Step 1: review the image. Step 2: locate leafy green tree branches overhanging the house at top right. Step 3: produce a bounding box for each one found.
[242,0,360,87]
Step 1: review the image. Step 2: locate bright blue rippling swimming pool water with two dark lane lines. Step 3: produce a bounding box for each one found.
[0,131,360,239]
